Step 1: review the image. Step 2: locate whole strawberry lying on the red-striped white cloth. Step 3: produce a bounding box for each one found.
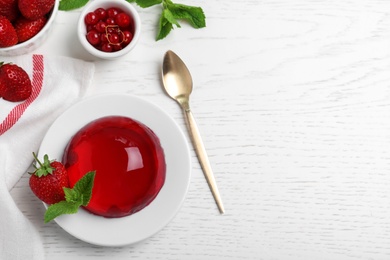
[0,62,32,102]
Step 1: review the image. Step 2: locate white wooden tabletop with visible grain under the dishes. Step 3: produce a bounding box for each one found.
[12,0,390,260]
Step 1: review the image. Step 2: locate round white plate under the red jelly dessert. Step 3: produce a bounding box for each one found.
[38,94,191,246]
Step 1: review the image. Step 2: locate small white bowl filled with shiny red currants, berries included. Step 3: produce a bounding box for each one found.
[78,0,141,59]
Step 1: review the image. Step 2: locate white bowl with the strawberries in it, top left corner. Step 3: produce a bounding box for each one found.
[0,0,60,56]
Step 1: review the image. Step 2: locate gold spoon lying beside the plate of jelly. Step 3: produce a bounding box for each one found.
[162,51,225,214]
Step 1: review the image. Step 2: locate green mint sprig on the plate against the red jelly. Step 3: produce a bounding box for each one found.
[44,171,95,223]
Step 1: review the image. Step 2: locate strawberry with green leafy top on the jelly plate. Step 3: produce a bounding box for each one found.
[29,153,69,204]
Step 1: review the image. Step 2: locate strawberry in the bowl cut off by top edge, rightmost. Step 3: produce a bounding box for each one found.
[18,0,55,20]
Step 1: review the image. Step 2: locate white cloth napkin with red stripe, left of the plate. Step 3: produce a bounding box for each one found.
[0,55,94,260]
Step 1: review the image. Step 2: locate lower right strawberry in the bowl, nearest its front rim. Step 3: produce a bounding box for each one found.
[14,16,47,42]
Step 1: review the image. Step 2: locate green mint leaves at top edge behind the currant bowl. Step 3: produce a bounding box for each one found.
[59,0,206,41]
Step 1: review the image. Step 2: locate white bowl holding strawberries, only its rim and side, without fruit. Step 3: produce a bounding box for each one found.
[0,0,60,56]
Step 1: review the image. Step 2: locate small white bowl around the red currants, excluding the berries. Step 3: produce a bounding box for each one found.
[77,0,141,59]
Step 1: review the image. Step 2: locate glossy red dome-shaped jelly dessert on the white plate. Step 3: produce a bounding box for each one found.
[62,116,166,218]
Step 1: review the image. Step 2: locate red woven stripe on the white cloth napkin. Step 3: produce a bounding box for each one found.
[0,55,44,135]
